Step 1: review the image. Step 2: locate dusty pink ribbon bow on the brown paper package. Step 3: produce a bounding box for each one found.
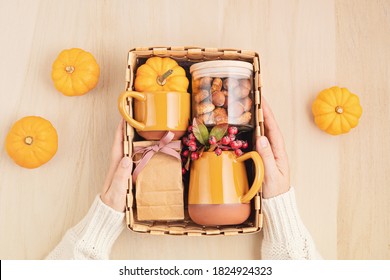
[133,131,180,184]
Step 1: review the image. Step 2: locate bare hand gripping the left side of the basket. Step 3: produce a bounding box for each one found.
[100,120,132,212]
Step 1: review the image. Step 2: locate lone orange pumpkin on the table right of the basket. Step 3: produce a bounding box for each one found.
[312,87,362,135]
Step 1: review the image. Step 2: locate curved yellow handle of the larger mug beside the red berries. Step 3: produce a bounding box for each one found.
[236,151,264,203]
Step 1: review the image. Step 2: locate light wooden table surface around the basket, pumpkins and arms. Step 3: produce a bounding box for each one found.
[0,0,390,259]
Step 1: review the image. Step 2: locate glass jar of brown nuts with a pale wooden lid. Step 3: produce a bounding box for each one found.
[190,60,254,130]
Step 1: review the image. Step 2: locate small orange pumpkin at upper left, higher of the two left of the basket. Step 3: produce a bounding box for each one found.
[51,48,100,96]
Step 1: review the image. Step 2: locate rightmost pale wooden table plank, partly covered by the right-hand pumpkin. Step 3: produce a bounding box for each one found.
[336,1,390,259]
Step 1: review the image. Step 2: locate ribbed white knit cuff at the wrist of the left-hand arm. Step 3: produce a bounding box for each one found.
[71,195,125,258]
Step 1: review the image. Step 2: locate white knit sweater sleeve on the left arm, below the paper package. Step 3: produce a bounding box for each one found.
[46,195,125,260]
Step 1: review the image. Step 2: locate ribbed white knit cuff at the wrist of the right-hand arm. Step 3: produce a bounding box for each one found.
[263,187,308,242]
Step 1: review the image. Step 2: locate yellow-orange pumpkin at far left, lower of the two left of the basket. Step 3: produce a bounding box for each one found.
[5,116,58,168]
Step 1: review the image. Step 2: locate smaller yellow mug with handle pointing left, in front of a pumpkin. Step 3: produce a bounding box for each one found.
[118,91,190,140]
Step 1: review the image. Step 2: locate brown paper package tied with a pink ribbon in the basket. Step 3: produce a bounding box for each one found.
[133,136,184,221]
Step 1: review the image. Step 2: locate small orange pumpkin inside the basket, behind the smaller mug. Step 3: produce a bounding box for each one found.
[134,56,189,92]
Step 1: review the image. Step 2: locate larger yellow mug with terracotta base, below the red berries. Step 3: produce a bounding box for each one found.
[188,151,264,226]
